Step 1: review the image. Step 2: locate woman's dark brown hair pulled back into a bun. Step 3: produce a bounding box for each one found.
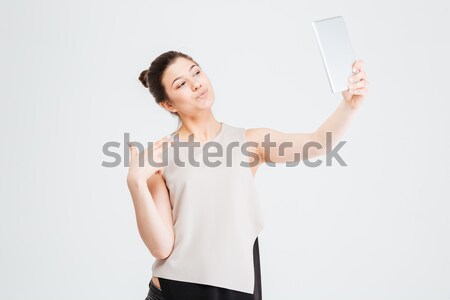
[139,51,200,131]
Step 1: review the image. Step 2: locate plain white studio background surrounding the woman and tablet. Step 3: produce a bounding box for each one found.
[0,0,450,300]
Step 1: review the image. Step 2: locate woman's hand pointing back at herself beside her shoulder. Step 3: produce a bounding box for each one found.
[127,135,170,184]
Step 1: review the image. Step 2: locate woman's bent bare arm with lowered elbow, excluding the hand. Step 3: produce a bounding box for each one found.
[127,174,175,259]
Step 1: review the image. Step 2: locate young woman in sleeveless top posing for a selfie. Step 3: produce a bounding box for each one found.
[127,51,368,300]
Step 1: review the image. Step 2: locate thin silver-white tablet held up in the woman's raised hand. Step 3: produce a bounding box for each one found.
[312,16,355,93]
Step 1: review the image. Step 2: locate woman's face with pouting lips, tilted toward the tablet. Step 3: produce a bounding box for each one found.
[161,57,214,116]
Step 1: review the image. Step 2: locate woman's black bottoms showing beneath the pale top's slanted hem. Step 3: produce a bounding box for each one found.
[146,238,262,300]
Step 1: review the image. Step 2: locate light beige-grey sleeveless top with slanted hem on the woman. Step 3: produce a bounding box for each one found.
[152,122,264,293]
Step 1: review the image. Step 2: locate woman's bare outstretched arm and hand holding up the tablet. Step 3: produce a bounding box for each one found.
[246,60,368,163]
